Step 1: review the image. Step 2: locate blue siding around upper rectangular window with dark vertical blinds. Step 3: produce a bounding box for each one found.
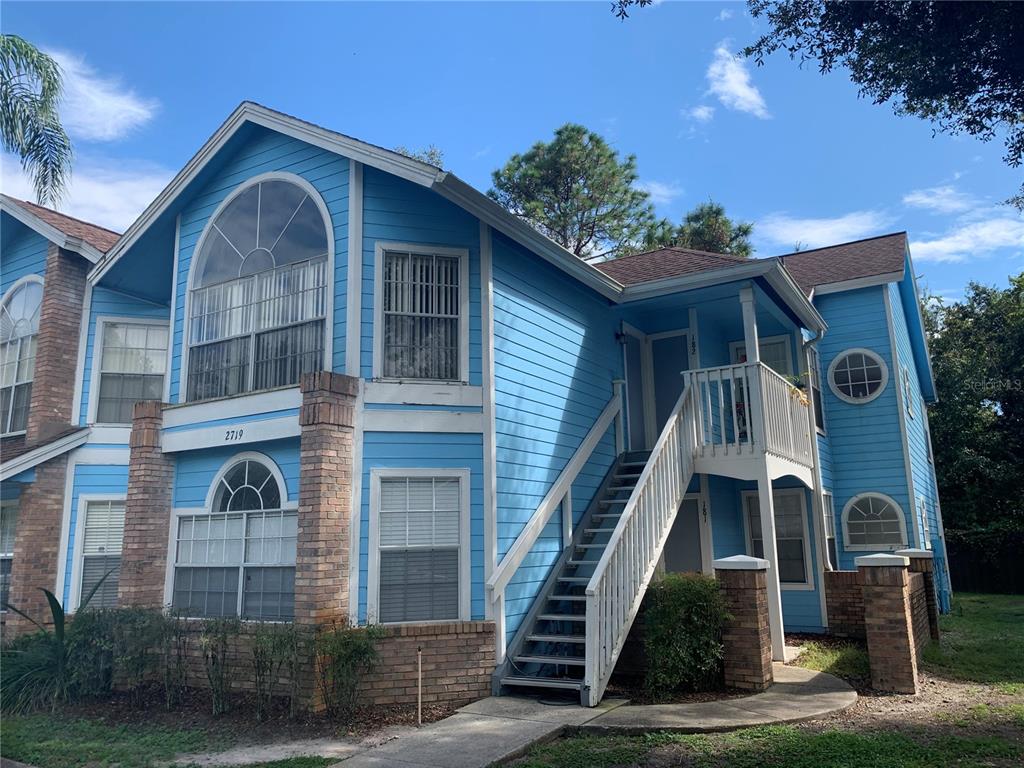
[359,167,482,385]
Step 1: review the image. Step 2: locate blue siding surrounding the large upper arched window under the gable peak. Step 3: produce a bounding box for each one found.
[171,129,348,402]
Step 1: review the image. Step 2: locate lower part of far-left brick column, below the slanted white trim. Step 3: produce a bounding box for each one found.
[5,454,68,636]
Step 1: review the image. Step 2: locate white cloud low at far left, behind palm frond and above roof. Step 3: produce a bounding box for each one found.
[0,154,174,231]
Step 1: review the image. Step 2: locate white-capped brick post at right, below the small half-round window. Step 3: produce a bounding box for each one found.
[856,554,918,693]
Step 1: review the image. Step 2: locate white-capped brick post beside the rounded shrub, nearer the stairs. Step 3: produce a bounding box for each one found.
[713,555,774,690]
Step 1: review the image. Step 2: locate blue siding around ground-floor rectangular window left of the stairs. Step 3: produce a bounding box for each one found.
[358,432,484,623]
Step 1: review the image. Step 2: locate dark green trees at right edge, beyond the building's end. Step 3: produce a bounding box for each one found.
[925,273,1024,530]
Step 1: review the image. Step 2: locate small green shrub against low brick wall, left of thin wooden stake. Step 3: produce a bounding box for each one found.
[314,625,385,717]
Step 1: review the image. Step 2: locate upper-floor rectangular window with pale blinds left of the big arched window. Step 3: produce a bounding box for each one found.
[96,323,168,424]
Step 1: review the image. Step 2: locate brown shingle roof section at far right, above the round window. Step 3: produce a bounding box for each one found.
[781,232,906,294]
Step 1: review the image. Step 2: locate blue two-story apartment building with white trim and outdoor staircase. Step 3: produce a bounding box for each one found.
[0,102,948,703]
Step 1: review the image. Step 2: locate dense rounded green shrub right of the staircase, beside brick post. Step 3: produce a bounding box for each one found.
[644,573,728,696]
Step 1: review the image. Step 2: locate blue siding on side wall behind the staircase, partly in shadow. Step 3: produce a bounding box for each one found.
[493,233,622,636]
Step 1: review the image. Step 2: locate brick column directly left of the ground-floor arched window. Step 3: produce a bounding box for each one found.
[118,400,174,607]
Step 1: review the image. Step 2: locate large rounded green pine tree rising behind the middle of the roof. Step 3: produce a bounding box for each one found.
[487,123,654,256]
